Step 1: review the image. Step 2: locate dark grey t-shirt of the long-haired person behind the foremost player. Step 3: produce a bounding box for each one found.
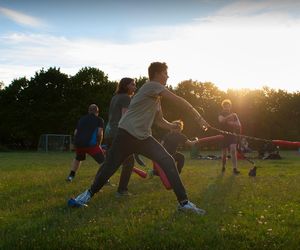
[106,93,131,138]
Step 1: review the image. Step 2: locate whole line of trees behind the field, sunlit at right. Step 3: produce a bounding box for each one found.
[0,67,300,150]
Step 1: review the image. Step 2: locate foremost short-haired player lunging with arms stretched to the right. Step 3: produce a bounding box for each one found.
[68,62,210,215]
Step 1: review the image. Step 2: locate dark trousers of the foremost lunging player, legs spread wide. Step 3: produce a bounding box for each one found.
[90,128,187,202]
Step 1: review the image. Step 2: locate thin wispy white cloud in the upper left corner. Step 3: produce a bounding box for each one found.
[0,6,45,28]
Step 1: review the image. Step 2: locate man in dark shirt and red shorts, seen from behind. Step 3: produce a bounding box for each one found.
[66,104,104,181]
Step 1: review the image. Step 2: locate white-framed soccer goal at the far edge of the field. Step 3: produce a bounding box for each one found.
[38,134,72,152]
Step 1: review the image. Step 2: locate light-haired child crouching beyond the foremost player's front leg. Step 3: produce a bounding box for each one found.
[152,120,199,175]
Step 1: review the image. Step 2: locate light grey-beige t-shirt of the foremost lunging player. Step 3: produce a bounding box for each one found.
[119,81,165,140]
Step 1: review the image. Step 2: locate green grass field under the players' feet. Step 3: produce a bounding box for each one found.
[0,151,300,249]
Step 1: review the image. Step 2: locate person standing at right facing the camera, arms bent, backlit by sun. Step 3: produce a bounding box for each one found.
[218,99,241,175]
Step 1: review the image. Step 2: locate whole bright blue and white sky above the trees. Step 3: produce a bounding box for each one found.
[0,0,300,92]
